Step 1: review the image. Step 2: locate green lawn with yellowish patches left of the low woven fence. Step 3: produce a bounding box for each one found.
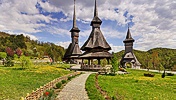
[0,64,71,100]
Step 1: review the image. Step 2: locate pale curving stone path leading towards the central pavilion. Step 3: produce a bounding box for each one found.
[56,72,91,100]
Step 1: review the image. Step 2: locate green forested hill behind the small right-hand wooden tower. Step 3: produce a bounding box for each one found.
[116,48,176,69]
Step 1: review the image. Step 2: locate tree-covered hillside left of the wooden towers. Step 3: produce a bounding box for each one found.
[0,32,65,61]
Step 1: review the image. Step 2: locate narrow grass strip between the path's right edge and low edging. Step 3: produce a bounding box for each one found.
[86,74,105,100]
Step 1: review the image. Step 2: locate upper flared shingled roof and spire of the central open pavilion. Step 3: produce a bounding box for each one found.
[81,0,111,51]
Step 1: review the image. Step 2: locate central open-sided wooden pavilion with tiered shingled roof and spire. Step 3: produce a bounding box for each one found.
[79,0,112,70]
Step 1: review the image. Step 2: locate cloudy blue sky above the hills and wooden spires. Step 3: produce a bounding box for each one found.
[0,0,176,52]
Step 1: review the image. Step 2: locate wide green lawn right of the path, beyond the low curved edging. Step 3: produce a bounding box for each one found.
[97,70,176,100]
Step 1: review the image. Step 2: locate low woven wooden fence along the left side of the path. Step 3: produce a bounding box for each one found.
[24,72,80,100]
